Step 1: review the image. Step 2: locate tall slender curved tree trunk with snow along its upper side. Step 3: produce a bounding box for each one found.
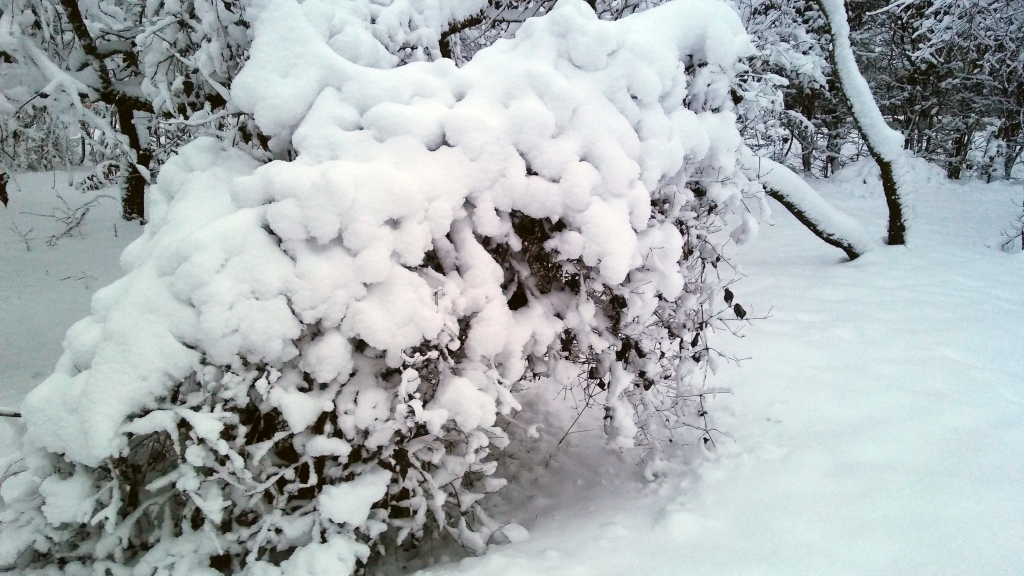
[816,0,909,245]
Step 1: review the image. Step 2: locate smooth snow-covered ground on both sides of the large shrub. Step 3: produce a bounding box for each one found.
[0,171,1024,576]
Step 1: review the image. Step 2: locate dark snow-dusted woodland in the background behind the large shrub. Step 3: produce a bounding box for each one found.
[6,1,1024,188]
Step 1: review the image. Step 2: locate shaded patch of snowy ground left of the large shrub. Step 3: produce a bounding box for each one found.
[0,172,142,407]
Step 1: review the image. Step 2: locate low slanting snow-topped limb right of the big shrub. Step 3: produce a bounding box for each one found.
[743,157,876,260]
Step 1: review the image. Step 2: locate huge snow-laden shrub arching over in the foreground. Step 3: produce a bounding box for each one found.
[0,0,759,575]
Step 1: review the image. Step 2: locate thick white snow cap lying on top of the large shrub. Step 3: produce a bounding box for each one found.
[24,0,750,465]
